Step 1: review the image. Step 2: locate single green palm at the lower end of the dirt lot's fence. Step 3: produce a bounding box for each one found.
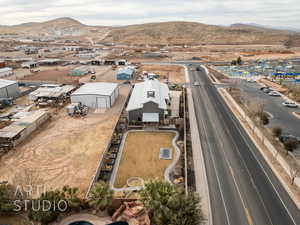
[88,181,114,211]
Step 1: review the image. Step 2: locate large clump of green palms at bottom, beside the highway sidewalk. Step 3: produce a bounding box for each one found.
[140,180,204,225]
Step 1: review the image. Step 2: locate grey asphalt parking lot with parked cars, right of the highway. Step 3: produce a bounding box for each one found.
[240,80,300,158]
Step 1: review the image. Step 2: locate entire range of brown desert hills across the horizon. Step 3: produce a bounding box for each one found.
[0,17,300,44]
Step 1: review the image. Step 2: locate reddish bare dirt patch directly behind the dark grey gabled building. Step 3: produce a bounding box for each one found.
[139,64,185,83]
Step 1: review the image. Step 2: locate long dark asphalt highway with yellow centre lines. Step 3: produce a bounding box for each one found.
[189,66,300,225]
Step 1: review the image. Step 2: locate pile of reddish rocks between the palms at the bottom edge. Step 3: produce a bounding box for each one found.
[112,201,151,225]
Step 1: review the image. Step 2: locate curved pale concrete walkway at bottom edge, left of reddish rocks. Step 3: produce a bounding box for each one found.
[53,213,112,225]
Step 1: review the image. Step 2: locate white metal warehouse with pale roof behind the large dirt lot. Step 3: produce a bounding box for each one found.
[71,82,119,109]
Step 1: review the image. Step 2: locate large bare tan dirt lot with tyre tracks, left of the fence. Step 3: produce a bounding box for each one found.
[0,86,130,197]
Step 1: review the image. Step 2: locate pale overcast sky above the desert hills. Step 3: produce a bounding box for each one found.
[0,0,300,29]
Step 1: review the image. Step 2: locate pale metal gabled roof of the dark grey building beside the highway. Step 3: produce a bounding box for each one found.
[126,79,170,111]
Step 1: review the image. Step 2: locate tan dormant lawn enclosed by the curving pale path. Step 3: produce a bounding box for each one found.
[115,132,175,188]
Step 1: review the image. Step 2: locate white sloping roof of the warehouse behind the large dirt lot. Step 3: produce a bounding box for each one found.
[71,82,118,96]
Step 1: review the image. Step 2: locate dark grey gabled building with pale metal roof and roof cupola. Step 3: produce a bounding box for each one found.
[126,79,170,123]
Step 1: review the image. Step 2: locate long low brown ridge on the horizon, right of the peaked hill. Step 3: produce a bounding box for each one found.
[105,22,300,44]
